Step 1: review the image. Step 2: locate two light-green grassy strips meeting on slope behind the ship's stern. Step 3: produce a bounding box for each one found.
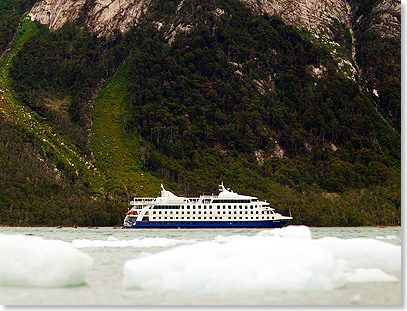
[0,18,166,202]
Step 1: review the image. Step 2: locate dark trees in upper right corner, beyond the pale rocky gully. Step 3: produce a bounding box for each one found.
[351,0,401,133]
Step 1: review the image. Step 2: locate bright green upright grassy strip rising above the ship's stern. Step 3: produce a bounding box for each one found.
[90,55,161,197]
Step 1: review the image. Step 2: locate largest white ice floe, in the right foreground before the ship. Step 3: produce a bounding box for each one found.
[123,226,401,293]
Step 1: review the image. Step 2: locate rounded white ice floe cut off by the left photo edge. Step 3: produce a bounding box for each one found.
[0,234,93,287]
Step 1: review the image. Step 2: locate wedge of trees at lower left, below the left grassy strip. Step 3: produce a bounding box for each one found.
[0,114,126,226]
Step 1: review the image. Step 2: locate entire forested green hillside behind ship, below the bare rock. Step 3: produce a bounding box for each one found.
[0,0,401,226]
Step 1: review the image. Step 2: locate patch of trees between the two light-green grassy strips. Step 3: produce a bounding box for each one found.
[10,23,142,155]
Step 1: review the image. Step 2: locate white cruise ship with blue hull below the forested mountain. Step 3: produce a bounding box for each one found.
[123,182,292,229]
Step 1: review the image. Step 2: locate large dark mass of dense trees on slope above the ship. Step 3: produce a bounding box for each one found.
[129,0,400,197]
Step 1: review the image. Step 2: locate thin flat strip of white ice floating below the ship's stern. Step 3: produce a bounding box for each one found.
[72,236,195,248]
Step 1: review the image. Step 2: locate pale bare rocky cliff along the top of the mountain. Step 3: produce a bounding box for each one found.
[29,0,401,86]
